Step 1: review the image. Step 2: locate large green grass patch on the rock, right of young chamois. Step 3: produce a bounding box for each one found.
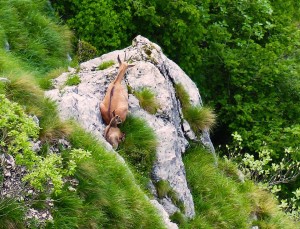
[119,115,157,177]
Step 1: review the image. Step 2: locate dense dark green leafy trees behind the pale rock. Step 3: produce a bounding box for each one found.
[51,0,300,217]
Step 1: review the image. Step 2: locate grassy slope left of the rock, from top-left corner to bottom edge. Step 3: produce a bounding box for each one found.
[0,0,164,229]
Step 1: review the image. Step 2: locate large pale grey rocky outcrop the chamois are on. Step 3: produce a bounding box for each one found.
[46,36,214,224]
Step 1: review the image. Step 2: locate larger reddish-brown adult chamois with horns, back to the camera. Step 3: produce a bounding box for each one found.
[100,55,134,125]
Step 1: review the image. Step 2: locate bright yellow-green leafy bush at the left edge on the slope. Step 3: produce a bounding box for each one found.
[0,95,89,192]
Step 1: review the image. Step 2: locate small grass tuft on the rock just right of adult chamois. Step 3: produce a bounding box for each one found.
[133,88,159,114]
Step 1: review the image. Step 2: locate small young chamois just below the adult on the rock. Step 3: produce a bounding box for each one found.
[104,111,125,149]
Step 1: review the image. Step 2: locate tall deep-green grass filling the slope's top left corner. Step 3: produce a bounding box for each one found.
[0,0,71,72]
